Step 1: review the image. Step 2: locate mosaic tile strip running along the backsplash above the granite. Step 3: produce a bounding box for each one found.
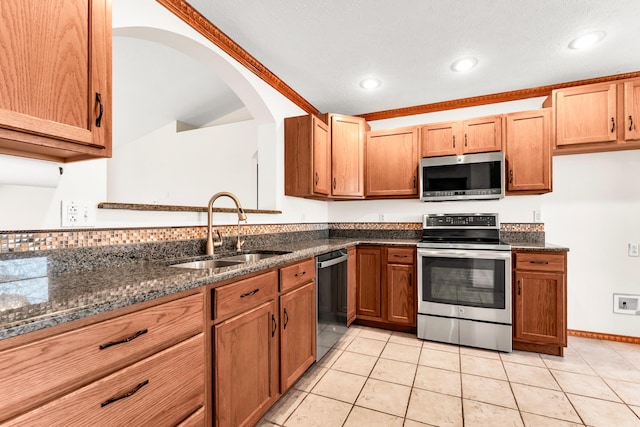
[0,222,544,253]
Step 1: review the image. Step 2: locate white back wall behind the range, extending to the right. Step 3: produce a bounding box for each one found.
[329,98,640,336]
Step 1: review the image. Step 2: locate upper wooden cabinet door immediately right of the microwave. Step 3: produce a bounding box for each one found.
[505,109,551,193]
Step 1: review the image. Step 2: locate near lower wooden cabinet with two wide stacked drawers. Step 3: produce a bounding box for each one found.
[0,293,205,426]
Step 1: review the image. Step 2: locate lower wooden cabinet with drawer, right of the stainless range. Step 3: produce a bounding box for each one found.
[513,251,567,356]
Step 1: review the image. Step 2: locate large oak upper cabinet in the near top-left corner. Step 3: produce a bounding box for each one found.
[0,0,112,162]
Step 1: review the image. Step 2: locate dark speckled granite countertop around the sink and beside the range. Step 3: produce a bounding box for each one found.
[0,238,568,340]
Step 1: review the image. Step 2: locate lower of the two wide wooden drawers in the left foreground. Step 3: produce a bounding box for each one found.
[6,333,205,427]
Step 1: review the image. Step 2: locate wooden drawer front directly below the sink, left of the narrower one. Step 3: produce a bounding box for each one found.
[213,271,278,320]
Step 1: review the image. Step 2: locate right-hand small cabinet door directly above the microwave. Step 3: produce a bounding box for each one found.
[461,116,502,153]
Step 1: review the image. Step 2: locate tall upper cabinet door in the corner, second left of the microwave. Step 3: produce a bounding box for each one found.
[331,115,366,198]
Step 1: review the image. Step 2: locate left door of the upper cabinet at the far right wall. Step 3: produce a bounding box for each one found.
[555,83,618,148]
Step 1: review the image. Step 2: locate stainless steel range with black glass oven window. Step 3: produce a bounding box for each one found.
[418,214,511,352]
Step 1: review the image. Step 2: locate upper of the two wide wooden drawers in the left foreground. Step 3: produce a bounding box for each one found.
[0,294,204,422]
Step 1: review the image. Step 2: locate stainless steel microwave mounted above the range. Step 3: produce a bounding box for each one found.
[420,152,505,202]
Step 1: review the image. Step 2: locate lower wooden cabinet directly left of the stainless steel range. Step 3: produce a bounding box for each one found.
[356,246,417,327]
